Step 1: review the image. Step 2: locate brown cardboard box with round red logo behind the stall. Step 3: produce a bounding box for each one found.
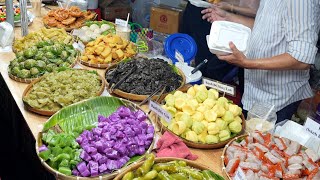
[150,7,182,34]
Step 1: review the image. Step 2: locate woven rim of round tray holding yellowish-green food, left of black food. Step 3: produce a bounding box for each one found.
[22,69,106,116]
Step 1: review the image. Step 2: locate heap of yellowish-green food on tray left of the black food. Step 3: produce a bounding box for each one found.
[23,69,102,111]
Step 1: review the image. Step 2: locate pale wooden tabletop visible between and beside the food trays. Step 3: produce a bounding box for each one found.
[0,5,226,177]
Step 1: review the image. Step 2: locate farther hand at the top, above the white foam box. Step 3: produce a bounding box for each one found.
[201,7,227,23]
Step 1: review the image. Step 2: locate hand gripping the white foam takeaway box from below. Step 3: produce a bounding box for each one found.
[218,42,248,67]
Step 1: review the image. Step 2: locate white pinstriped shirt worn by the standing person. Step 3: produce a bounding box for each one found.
[242,0,320,111]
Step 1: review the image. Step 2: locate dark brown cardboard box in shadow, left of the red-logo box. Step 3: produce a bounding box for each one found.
[100,0,131,21]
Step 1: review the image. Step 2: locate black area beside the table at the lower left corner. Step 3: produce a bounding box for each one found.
[0,75,55,180]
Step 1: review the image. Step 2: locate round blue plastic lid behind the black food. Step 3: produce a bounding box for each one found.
[164,33,198,65]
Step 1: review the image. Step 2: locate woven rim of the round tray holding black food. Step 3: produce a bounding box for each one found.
[105,65,186,101]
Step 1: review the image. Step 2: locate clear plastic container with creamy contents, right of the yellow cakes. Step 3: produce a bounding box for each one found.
[246,102,277,133]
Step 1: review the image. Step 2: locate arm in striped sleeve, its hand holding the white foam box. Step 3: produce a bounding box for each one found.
[218,0,320,70]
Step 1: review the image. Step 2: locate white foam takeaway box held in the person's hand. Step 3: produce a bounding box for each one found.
[207,21,251,55]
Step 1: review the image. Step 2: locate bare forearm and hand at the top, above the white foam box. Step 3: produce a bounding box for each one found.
[201,7,254,29]
